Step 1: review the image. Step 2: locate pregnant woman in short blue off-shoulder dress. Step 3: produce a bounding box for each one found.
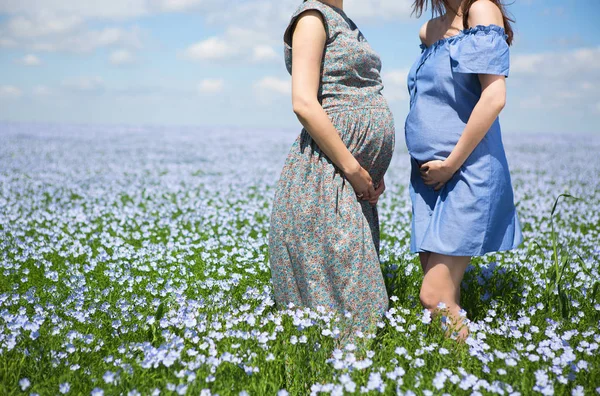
[405,0,522,339]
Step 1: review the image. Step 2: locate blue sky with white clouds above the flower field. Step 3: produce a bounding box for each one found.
[0,0,600,133]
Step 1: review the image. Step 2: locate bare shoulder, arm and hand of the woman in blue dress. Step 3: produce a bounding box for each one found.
[421,0,506,190]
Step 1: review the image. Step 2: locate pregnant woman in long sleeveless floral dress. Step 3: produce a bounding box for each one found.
[269,0,395,345]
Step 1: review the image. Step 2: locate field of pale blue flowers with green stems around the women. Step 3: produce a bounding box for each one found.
[0,124,600,395]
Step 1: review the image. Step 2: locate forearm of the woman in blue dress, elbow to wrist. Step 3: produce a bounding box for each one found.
[445,95,504,172]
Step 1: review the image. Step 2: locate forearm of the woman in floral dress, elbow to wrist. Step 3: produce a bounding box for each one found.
[294,100,360,173]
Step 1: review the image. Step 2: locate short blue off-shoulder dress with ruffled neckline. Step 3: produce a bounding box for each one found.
[405,25,523,256]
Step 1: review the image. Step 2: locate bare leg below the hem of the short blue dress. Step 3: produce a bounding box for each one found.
[419,253,471,339]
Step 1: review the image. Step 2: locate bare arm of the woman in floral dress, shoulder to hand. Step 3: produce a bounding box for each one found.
[292,10,375,199]
